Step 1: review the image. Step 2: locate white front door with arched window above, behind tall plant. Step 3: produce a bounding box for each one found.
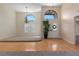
[43,9,59,38]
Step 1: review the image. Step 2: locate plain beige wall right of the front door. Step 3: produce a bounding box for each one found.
[61,3,79,44]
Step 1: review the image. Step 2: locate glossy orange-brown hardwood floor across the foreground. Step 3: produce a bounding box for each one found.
[0,39,79,51]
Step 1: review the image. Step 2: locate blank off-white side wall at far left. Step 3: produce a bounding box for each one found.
[0,5,16,39]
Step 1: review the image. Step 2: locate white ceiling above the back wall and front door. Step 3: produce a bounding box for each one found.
[0,3,61,12]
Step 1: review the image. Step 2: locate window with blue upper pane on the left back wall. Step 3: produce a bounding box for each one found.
[24,15,36,33]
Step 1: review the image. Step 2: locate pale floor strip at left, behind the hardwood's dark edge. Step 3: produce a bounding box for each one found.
[0,35,41,41]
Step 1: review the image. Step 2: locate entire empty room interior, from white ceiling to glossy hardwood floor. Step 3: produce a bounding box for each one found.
[0,3,79,51]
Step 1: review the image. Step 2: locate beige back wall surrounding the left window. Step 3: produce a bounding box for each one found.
[16,12,41,34]
